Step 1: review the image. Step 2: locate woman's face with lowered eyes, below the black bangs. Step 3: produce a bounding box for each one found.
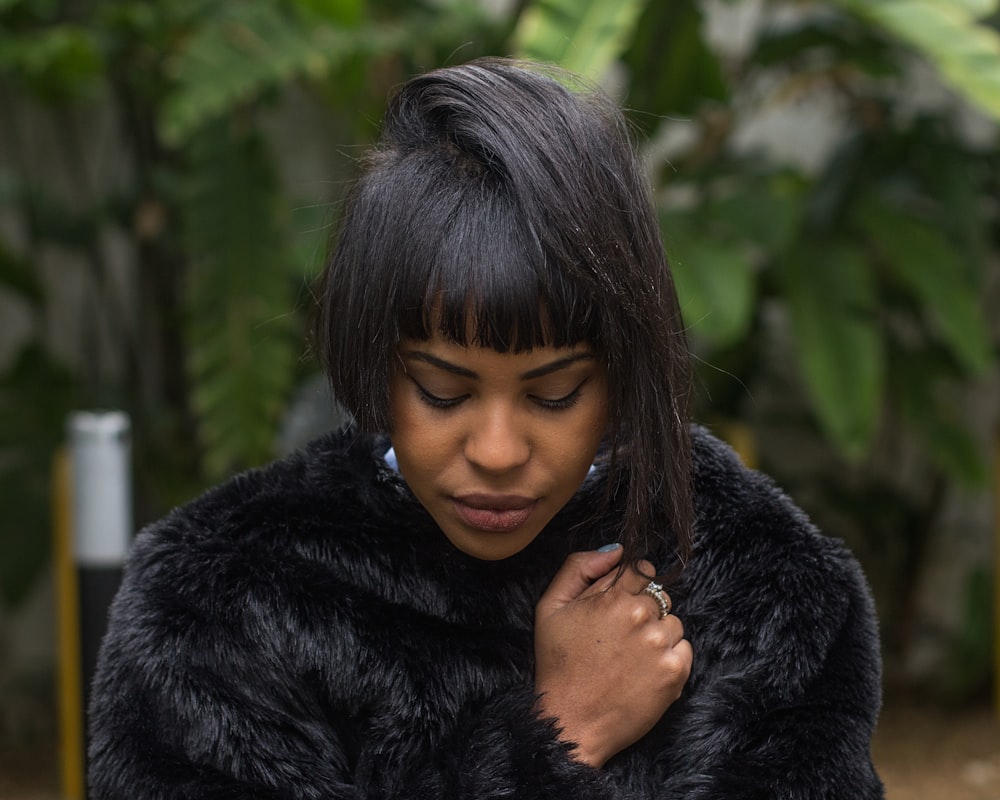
[390,335,608,560]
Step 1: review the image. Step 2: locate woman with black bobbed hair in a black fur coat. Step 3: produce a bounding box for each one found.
[90,60,882,800]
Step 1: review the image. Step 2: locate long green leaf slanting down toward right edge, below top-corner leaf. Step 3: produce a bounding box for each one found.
[855,198,994,373]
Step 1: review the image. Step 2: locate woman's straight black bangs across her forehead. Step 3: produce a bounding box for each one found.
[375,152,603,353]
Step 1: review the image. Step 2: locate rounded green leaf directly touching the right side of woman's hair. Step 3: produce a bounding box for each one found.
[660,213,757,348]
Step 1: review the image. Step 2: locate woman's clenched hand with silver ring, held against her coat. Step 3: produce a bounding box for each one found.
[535,547,692,767]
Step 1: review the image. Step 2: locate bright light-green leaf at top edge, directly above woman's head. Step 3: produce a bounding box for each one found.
[513,0,646,80]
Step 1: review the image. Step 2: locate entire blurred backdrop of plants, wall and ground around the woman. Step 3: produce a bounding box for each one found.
[0,0,1000,800]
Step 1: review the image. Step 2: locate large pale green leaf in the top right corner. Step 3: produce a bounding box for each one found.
[835,0,1000,119]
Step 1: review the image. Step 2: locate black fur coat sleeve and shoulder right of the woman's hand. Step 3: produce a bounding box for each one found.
[654,436,883,800]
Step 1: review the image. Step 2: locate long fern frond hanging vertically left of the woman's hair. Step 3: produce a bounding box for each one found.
[181,121,301,477]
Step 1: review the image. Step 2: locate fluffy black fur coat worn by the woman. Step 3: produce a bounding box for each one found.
[90,430,882,800]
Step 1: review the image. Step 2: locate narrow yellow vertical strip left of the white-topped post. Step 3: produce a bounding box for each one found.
[52,448,86,800]
